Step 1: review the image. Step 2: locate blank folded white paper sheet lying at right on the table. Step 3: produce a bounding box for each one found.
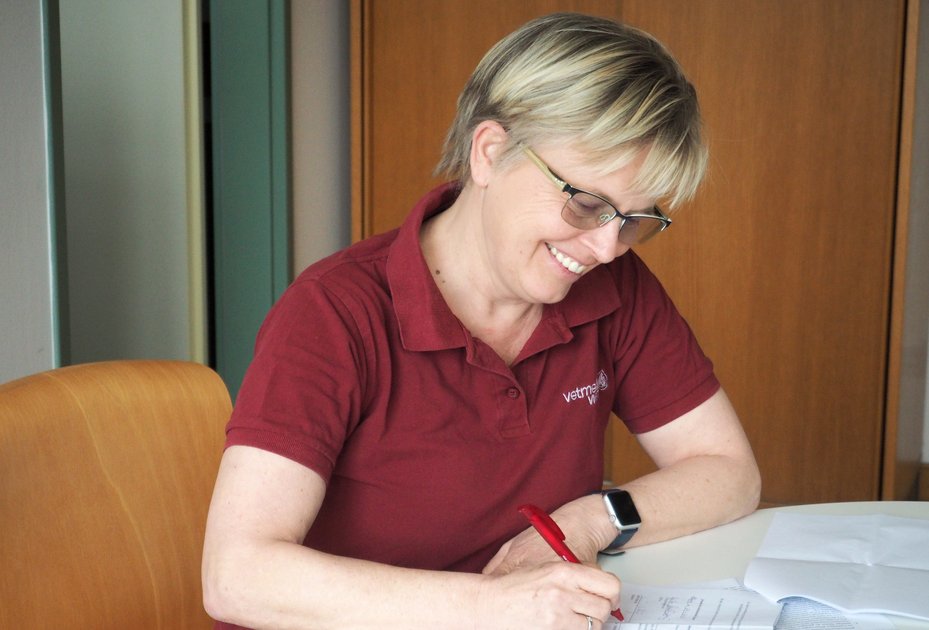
[745,512,929,619]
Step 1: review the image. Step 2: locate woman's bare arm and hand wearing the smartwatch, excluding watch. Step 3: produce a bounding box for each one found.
[484,389,761,573]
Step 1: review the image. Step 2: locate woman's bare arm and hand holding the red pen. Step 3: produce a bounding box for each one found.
[203,446,619,630]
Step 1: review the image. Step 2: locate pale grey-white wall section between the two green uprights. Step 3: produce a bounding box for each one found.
[58,0,190,363]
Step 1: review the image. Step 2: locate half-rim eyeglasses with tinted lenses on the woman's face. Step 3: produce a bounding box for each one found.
[523,147,671,245]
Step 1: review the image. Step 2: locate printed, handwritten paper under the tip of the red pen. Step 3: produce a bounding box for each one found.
[604,582,781,630]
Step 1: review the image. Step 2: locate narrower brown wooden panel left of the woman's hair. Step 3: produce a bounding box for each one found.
[353,0,616,239]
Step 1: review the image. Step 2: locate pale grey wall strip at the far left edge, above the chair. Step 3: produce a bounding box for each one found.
[0,2,60,383]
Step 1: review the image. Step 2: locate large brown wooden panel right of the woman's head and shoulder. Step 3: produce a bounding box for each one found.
[623,0,903,503]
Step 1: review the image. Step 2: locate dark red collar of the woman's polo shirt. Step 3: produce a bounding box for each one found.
[387,182,621,358]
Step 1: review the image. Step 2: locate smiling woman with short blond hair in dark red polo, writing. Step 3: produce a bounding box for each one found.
[204,14,760,630]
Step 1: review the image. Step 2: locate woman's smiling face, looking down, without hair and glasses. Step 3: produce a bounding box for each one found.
[481,137,655,304]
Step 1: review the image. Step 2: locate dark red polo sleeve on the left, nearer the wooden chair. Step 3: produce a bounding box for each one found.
[226,280,366,482]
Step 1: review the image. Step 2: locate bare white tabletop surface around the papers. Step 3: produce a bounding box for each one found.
[600,501,929,629]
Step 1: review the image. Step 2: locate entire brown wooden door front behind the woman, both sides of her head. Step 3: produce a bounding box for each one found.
[353,0,904,503]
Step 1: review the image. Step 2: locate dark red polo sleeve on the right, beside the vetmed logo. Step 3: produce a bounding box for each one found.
[613,252,720,433]
